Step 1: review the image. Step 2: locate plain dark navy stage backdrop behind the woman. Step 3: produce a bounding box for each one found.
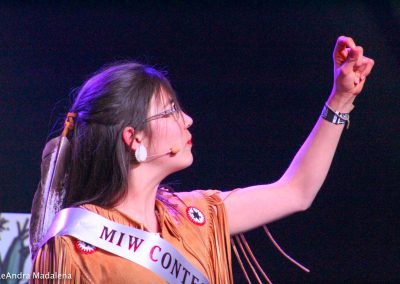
[0,1,400,283]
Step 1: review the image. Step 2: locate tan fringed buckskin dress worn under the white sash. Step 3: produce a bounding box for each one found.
[30,190,233,284]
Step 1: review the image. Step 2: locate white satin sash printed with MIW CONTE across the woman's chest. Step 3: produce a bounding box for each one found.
[40,208,208,284]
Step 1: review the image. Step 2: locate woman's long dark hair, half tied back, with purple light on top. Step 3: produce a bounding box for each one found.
[64,62,179,208]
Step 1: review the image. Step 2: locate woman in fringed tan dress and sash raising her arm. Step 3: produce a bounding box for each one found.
[31,36,374,283]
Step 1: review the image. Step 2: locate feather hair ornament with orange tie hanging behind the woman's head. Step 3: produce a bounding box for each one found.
[29,112,77,259]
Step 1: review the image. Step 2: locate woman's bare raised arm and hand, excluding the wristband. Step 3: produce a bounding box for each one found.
[221,36,374,234]
